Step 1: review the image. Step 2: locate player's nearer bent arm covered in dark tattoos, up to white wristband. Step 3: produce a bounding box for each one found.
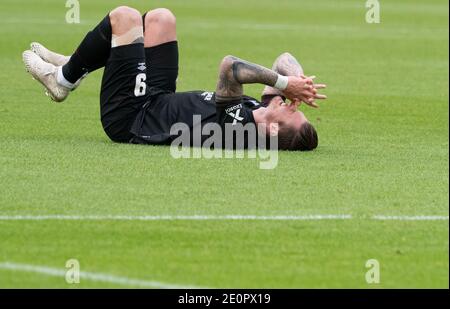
[216,56,278,101]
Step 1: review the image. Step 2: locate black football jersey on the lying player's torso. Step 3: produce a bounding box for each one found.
[131,91,261,147]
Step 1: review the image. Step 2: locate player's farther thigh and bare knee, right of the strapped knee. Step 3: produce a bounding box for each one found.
[144,8,178,92]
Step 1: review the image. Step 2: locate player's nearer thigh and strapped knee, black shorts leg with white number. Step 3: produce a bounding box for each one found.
[100,7,148,142]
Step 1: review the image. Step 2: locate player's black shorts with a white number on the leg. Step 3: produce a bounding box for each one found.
[100,41,178,143]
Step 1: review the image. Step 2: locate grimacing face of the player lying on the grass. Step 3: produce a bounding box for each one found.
[267,97,308,129]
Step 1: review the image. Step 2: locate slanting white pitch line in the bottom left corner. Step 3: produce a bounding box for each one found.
[0,262,201,289]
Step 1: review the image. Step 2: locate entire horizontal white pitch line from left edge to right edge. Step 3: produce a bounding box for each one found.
[0,214,449,221]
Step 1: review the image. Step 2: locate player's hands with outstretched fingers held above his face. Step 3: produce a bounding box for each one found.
[283,75,327,108]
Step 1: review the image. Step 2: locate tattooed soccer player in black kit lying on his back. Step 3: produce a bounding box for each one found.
[23,6,326,150]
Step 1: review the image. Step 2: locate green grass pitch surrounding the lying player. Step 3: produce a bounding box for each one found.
[0,0,449,288]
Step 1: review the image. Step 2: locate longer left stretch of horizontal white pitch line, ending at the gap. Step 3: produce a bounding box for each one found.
[0,215,352,221]
